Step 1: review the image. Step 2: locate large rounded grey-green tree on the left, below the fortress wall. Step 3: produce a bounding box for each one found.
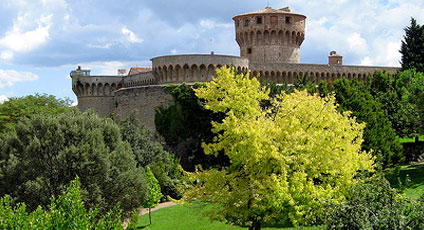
[0,110,146,213]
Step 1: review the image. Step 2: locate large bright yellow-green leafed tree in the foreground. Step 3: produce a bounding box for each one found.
[186,68,373,229]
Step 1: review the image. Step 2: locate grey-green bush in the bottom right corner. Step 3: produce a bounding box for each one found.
[323,176,424,229]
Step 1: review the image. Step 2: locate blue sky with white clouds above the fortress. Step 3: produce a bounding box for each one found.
[0,0,424,103]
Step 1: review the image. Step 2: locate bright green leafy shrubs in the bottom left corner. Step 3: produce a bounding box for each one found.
[0,178,131,230]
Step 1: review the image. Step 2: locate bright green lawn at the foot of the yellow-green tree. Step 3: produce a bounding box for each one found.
[137,203,320,230]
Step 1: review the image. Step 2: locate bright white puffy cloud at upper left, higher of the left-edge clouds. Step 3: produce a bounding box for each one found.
[0,15,52,53]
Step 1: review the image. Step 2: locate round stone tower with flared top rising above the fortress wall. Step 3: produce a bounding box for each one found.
[233,7,306,64]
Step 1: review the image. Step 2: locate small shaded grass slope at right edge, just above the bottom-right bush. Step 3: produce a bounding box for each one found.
[386,163,424,199]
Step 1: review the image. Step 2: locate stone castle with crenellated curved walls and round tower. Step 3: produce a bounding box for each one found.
[70,7,398,130]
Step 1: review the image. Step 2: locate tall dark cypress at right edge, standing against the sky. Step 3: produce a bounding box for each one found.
[400,18,424,72]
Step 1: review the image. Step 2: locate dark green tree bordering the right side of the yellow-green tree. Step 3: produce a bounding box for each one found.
[334,78,403,167]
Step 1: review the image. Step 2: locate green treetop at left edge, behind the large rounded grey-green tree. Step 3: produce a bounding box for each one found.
[0,94,71,133]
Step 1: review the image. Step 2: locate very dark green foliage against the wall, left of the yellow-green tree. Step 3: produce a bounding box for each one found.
[155,84,228,171]
